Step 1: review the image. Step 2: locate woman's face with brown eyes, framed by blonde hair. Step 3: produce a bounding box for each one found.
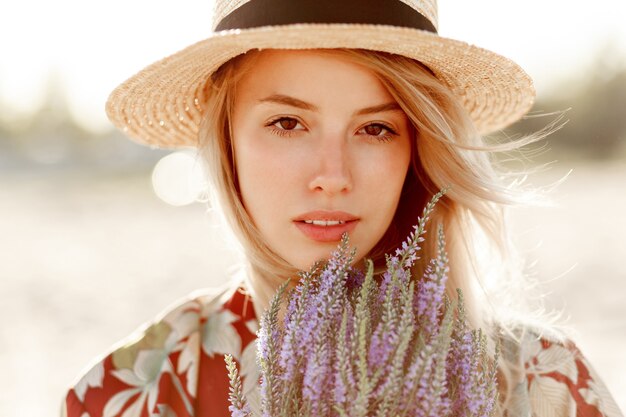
[232,50,411,270]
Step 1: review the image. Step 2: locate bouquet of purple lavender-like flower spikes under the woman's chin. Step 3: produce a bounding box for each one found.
[226,191,497,417]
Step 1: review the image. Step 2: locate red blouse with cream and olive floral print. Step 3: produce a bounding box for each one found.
[63,290,622,417]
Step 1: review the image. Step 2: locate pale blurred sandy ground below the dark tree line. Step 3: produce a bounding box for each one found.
[0,158,626,417]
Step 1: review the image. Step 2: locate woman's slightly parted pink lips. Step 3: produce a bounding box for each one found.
[293,210,360,242]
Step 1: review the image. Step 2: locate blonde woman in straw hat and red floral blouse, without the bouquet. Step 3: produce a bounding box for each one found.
[65,0,621,417]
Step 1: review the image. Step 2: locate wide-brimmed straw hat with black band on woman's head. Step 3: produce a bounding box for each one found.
[106,0,535,148]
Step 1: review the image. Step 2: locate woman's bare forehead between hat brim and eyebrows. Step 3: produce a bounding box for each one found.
[232,50,393,107]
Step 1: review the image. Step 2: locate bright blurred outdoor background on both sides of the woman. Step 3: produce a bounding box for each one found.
[0,0,626,417]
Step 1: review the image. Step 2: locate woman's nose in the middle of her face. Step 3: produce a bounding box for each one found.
[309,138,353,195]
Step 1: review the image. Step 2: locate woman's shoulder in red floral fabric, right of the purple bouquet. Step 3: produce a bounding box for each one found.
[501,326,622,417]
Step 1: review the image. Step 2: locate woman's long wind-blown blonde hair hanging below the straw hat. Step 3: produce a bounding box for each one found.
[200,49,538,406]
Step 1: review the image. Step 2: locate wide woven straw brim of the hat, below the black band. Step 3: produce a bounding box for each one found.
[106,24,535,148]
